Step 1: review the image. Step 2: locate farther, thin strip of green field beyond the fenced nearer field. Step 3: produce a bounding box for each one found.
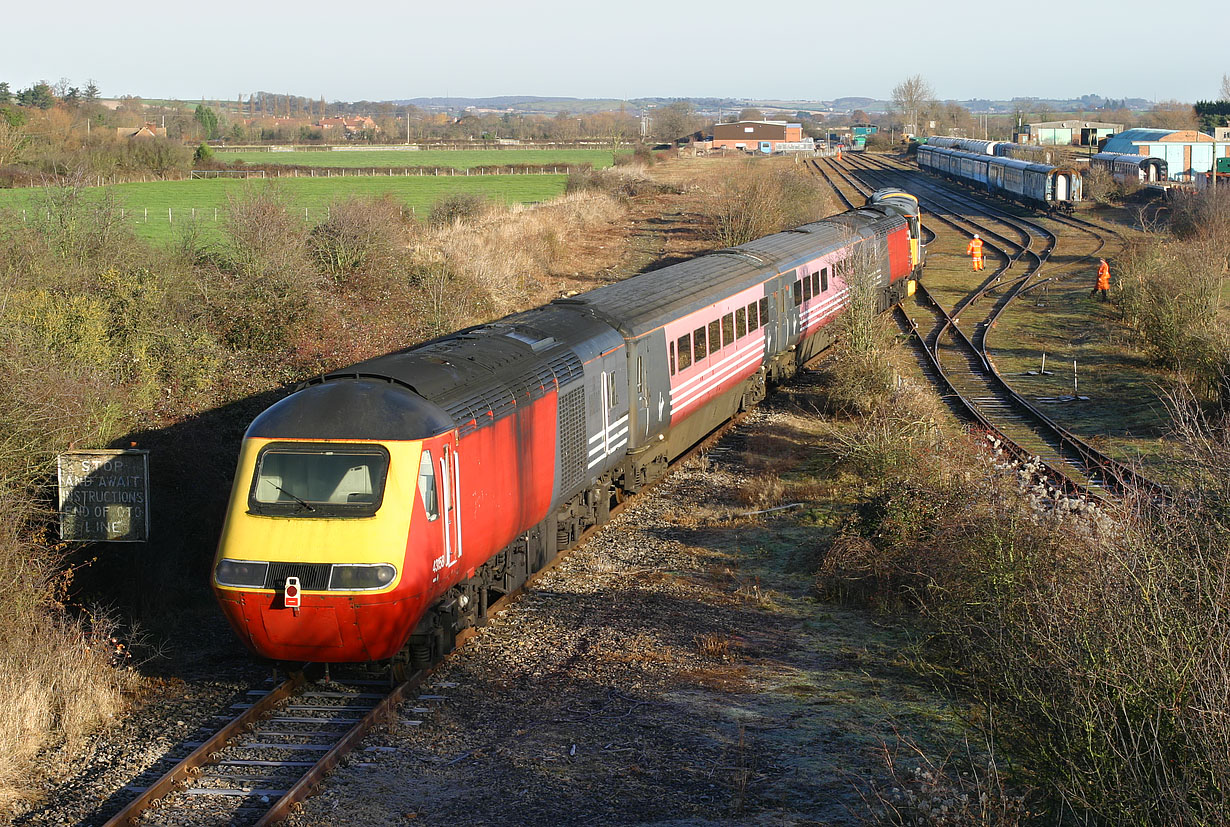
[214,149,614,170]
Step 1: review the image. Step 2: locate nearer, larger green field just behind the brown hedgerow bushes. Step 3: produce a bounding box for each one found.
[0,175,567,242]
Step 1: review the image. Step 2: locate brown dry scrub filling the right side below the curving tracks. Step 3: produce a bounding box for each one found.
[817,196,1230,827]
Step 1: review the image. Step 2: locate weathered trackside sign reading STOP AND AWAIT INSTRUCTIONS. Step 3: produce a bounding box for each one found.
[57,449,150,543]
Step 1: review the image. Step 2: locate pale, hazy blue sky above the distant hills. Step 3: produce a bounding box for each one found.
[0,0,1230,102]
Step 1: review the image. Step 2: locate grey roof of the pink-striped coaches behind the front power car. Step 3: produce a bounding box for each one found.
[556,207,905,337]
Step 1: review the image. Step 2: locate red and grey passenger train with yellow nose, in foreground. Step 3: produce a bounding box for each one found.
[212,188,925,668]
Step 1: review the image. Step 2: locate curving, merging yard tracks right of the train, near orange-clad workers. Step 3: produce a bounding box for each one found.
[812,153,1155,498]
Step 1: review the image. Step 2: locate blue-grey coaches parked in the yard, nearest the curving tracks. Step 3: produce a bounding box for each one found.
[918,142,1081,212]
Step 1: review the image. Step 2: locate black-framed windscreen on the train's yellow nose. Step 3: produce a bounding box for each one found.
[247,443,389,517]
